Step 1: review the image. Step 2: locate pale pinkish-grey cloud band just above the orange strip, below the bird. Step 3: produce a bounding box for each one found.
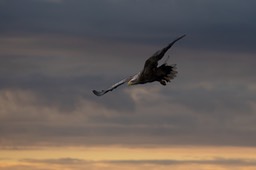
[0,87,255,146]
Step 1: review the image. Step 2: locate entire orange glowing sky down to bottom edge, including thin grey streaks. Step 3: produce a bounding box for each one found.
[0,146,256,170]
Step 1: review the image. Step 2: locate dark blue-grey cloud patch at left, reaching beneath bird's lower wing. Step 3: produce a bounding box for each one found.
[1,74,135,111]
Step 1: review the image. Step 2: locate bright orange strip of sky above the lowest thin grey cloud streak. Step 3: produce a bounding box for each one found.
[0,146,256,161]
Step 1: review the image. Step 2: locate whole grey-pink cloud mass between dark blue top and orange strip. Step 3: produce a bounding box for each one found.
[0,45,255,146]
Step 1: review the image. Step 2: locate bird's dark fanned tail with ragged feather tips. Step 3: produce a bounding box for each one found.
[158,63,178,86]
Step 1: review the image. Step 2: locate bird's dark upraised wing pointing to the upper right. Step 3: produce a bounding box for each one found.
[142,35,186,75]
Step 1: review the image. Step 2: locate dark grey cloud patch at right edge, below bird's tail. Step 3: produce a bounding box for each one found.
[169,84,255,114]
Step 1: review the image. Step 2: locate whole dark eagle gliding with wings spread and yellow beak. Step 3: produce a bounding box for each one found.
[93,35,186,96]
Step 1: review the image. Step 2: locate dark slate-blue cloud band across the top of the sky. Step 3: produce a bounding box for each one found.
[1,0,256,51]
